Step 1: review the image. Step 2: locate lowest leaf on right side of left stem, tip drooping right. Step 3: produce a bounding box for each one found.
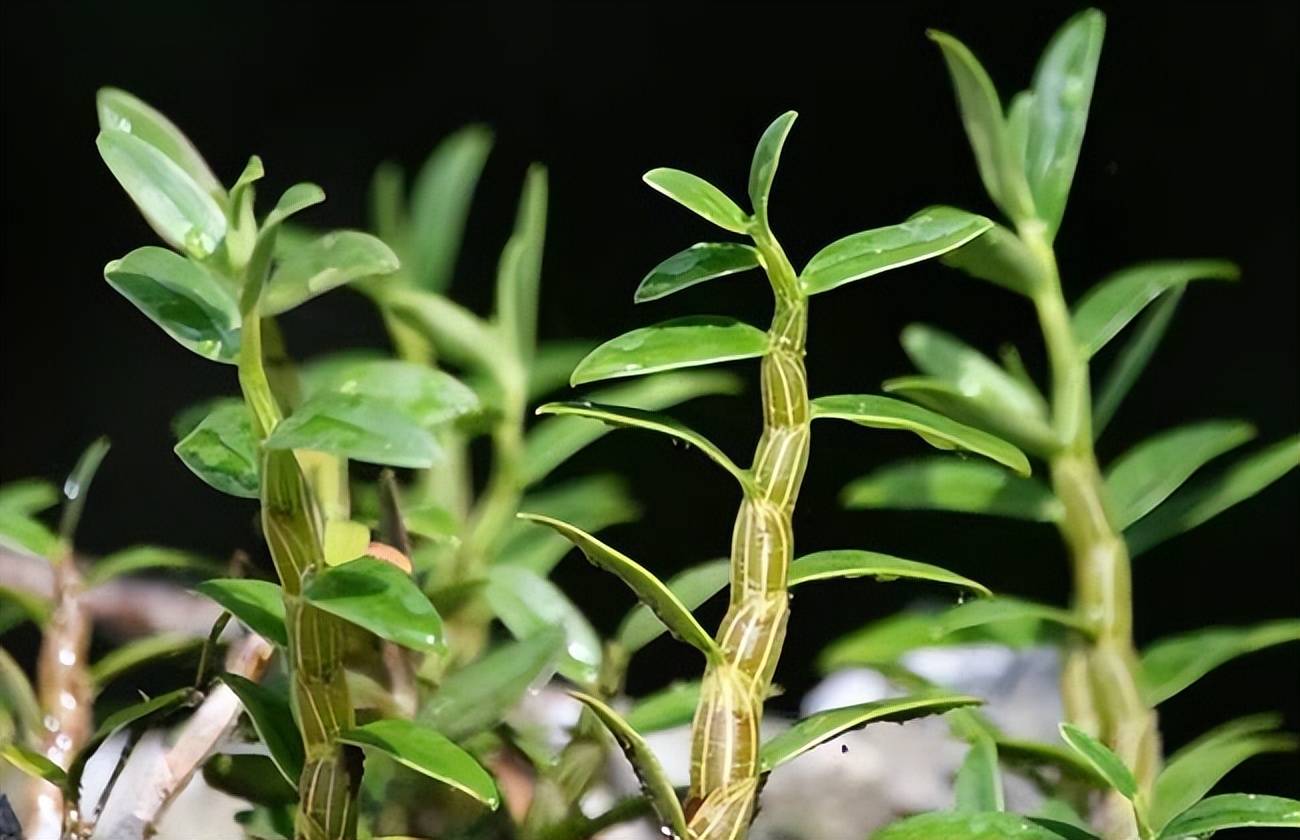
[339,720,501,810]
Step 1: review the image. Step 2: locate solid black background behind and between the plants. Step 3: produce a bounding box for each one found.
[0,3,1300,794]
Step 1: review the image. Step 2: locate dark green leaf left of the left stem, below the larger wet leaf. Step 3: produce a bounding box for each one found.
[174,399,261,499]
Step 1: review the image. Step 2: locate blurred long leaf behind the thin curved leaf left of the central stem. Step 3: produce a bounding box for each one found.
[523,371,740,486]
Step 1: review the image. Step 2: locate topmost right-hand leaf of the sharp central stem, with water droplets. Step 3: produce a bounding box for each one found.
[800,207,993,295]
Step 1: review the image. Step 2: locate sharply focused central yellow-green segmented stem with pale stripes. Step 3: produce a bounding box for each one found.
[688,230,810,840]
